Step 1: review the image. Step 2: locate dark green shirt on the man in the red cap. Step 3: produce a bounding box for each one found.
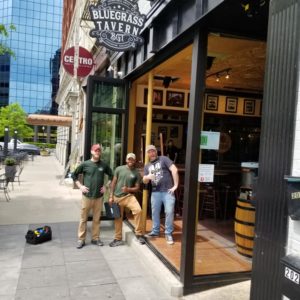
[72,159,113,198]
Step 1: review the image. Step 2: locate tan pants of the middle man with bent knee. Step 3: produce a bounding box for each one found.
[114,194,143,240]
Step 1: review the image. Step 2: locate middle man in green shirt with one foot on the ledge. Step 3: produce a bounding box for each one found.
[109,153,145,247]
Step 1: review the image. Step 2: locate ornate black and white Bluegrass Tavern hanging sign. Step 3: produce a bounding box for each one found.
[89,0,146,52]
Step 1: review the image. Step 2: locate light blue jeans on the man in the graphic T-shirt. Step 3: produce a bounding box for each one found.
[151,192,175,235]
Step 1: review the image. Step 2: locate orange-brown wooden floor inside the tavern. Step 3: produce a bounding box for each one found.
[129,217,252,275]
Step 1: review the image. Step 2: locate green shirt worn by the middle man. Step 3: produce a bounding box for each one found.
[114,165,141,197]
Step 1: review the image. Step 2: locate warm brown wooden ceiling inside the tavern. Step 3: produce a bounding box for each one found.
[137,34,266,94]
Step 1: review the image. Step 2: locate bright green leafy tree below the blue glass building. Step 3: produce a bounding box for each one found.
[0,103,33,138]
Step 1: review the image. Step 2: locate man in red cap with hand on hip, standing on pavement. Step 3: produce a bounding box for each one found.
[72,144,113,249]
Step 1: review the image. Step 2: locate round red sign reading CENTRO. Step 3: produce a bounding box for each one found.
[63,47,94,77]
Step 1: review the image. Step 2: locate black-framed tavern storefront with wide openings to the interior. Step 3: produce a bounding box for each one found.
[56,0,299,299]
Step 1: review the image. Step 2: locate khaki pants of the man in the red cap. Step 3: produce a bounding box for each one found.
[78,195,102,241]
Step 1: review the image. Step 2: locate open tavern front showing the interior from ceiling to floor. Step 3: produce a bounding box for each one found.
[126,34,266,275]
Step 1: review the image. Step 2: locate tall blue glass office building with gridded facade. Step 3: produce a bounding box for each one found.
[0,0,63,113]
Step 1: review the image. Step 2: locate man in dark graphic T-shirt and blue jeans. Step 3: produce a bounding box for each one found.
[143,145,178,245]
